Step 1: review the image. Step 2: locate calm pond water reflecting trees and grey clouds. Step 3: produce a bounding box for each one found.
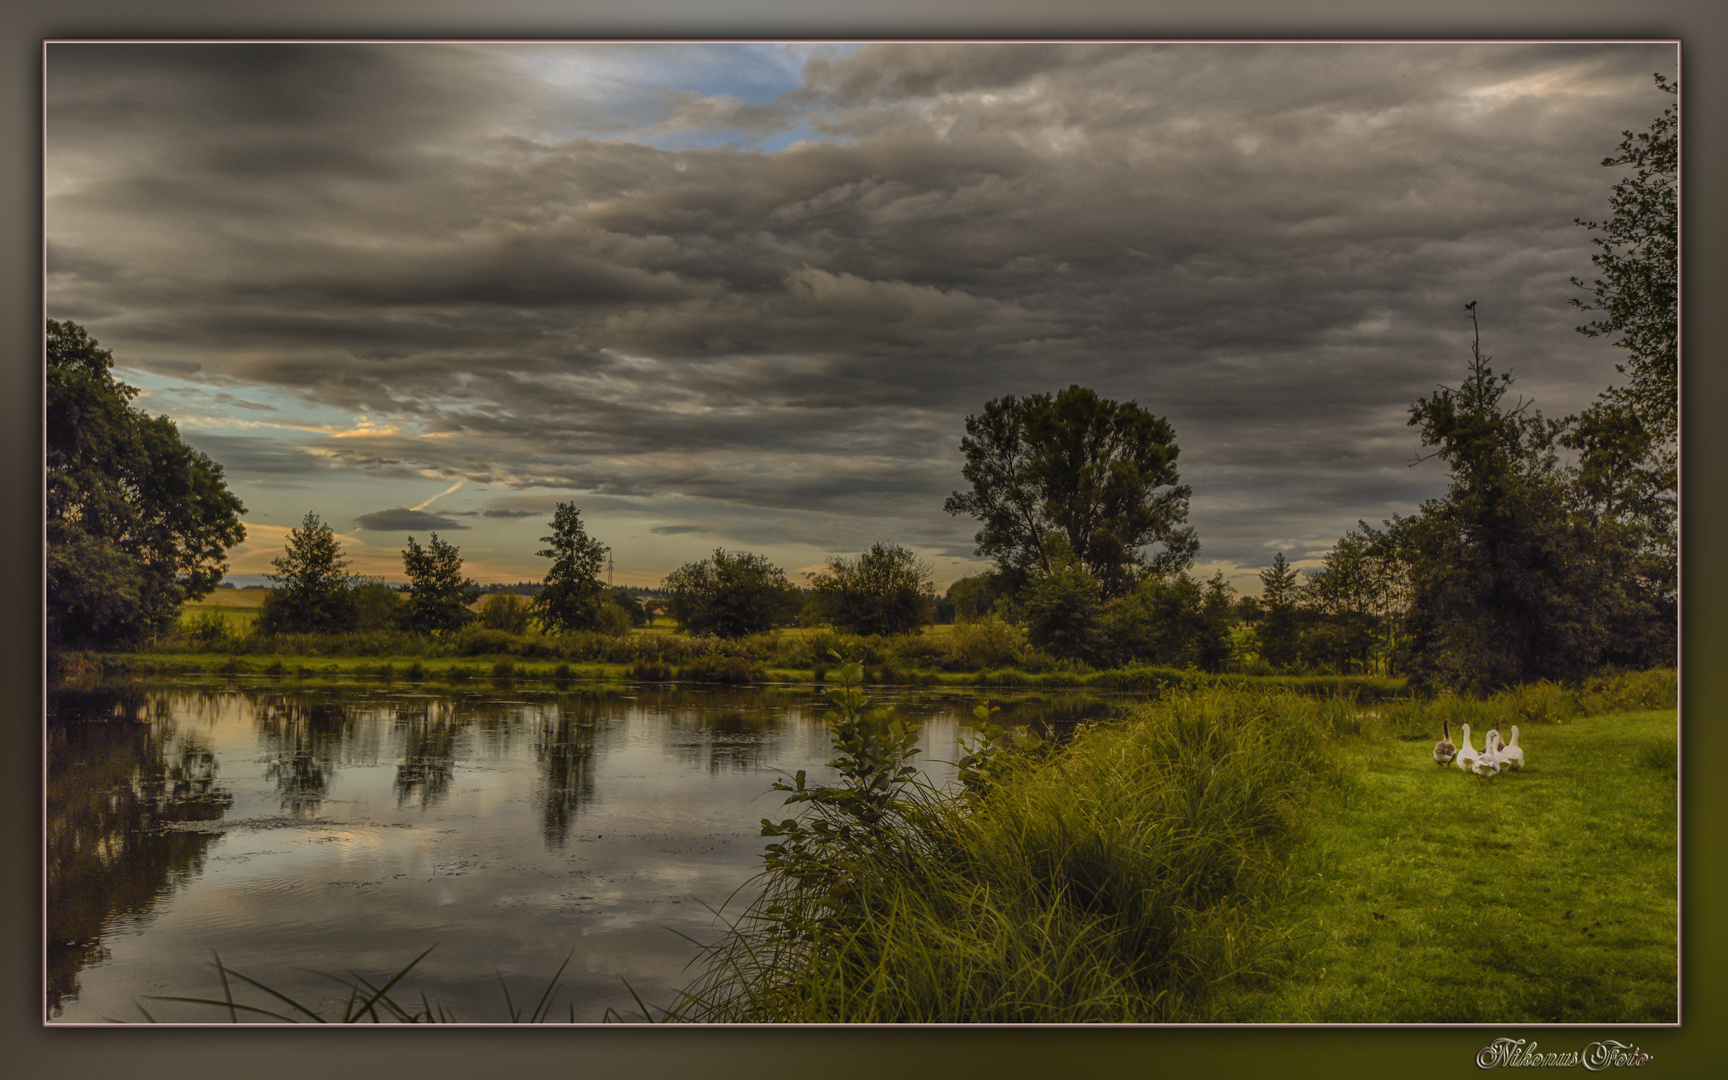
[45,681,1115,1023]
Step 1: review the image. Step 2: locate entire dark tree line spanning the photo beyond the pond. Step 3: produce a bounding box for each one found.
[47,76,1678,689]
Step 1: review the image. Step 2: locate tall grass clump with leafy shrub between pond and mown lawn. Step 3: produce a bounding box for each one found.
[674,677,1348,1023]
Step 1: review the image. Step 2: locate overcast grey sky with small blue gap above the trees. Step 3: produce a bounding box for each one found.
[43,41,1678,593]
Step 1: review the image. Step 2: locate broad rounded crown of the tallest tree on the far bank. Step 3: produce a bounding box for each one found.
[943,385,1199,598]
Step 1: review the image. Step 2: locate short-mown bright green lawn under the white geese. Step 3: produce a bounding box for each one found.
[1220,710,1680,1023]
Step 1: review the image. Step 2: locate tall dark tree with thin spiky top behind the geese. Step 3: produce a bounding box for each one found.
[1391,314,1630,689]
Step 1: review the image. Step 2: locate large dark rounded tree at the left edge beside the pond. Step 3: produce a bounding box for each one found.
[43,320,245,648]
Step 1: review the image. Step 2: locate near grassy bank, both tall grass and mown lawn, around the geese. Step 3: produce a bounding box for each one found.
[674,670,1678,1023]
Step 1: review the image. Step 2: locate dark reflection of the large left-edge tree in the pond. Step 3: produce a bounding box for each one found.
[45,688,233,1016]
